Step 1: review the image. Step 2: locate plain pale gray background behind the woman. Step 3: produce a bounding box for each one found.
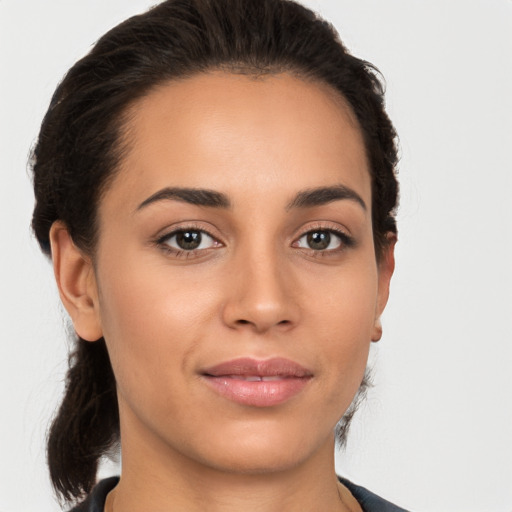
[0,0,512,512]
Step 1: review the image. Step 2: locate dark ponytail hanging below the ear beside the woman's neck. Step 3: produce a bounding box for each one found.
[47,338,119,501]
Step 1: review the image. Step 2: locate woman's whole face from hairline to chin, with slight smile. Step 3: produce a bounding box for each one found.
[75,72,391,472]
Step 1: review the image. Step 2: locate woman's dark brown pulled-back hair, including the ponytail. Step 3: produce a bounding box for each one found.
[32,0,398,500]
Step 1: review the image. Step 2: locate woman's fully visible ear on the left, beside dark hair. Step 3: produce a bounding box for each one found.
[50,221,103,341]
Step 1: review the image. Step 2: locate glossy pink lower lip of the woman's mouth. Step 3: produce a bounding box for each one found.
[204,375,311,407]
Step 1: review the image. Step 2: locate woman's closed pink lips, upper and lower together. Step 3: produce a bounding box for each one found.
[201,357,313,407]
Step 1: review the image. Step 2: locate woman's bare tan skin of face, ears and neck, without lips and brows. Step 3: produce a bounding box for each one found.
[51,72,394,512]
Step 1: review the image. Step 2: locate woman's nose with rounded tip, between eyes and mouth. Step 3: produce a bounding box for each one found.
[222,247,299,334]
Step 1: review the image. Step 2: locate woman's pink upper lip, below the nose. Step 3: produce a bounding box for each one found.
[201,357,312,378]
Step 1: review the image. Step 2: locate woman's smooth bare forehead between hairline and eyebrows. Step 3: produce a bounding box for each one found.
[109,71,371,209]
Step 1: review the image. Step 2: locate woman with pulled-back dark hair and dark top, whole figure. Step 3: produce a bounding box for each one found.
[33,0,401,512]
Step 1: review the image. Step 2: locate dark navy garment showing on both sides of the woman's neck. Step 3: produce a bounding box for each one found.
[70,476,407,512]
